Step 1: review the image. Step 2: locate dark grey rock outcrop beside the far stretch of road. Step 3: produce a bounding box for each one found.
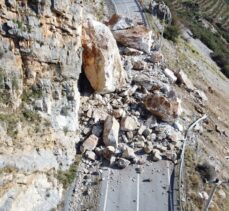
[149,0,172,23]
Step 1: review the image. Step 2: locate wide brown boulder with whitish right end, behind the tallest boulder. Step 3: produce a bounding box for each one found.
[113,25,153,53]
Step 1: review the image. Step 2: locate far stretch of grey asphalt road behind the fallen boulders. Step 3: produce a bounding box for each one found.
[112,0,145,24]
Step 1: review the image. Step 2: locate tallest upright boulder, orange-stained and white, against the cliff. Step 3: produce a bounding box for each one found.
[82,19,125,93]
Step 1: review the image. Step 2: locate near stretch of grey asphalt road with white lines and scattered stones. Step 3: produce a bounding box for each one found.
[98,161,174,211]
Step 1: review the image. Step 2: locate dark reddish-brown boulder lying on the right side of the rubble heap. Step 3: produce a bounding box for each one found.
[144,92,181,122]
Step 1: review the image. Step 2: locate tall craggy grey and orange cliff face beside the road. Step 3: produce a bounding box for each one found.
[0,0,82,210]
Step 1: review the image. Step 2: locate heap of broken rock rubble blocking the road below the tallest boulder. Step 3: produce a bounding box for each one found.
[76,15,191,169]
